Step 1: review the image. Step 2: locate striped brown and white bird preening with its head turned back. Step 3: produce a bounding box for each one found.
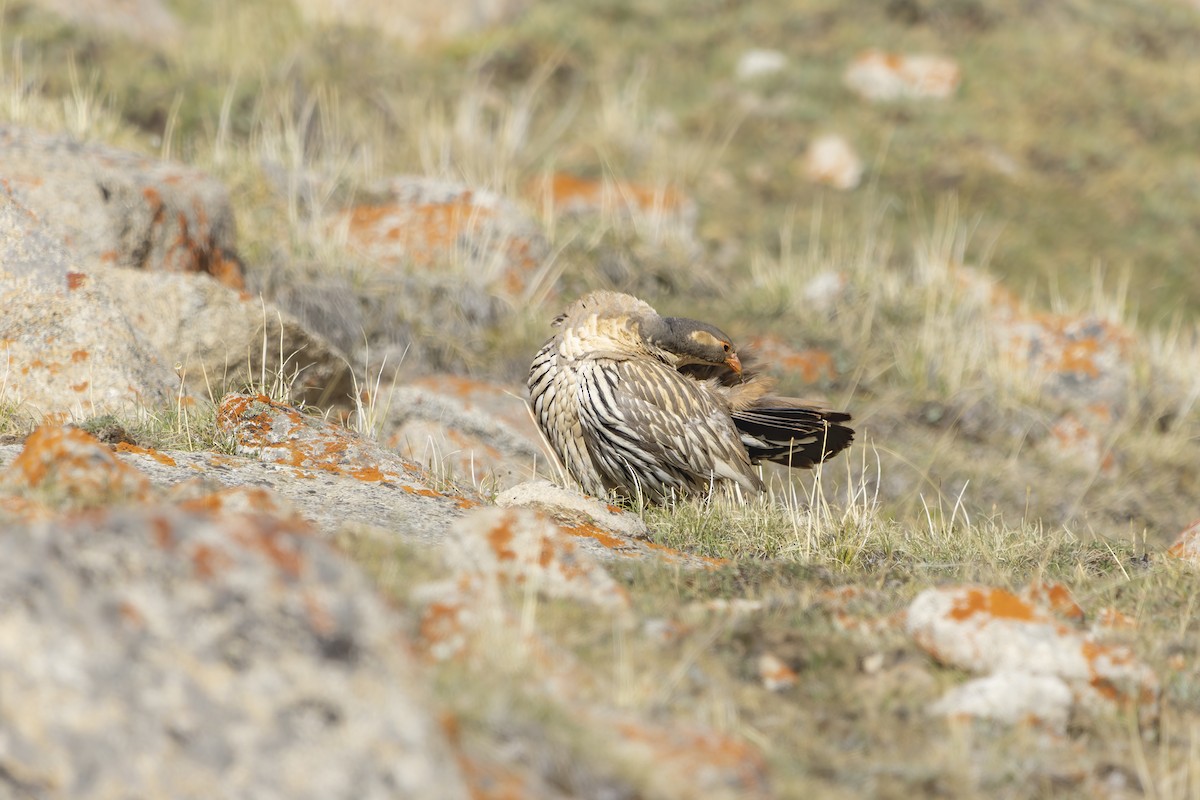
[528,290,854,500]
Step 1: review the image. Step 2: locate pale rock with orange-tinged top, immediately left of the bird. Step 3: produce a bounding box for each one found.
[377,375,548,489]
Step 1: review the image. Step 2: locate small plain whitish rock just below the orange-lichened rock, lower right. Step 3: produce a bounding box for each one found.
[929,669,1073,733]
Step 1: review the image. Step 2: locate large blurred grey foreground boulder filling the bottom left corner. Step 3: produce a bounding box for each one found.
[0,505,468,800]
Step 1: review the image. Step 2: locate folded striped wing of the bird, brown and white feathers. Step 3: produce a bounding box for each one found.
[580,359,762,491]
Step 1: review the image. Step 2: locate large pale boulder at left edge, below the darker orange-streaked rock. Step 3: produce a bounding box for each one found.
[0,183,353,419]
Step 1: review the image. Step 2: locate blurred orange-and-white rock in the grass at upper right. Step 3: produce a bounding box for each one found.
[842,50,961,101]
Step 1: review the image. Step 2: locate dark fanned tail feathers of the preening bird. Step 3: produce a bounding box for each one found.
[733,407,854,469]
